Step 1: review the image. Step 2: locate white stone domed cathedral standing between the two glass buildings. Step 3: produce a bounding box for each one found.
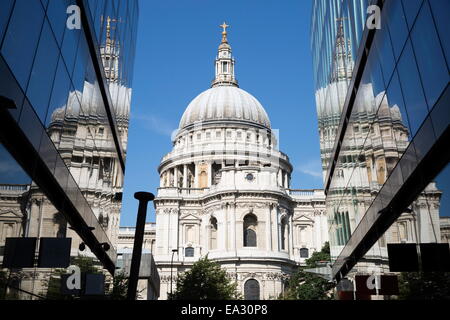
[154,24,328,299]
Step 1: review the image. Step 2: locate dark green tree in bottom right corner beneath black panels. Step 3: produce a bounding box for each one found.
[398,272,450,300]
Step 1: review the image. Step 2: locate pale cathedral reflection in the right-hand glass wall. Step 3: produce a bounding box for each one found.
[316,11,441,272]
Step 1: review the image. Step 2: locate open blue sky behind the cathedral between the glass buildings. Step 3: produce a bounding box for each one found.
[121,0,322,226]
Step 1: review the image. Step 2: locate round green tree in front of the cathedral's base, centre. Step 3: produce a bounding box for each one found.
[169,256,241,300]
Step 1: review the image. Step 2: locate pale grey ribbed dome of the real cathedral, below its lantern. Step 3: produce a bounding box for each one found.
[180,85,270,129]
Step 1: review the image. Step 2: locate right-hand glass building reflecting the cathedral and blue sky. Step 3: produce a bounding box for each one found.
[311,0,450,298]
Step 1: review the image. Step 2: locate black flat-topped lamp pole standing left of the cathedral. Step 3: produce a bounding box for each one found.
[127,192,155,300]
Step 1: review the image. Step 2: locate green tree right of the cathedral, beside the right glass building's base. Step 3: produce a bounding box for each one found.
[279,242,334,300]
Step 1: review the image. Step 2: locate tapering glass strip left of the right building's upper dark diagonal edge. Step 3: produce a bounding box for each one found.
[311,0,369,180]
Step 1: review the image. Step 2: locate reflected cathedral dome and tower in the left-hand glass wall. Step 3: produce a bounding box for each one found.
[48,17,131,245]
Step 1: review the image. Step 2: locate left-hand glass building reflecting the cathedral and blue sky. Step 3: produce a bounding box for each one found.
[0,0,139,299]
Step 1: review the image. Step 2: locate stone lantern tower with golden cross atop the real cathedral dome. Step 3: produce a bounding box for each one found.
[212,22,238,88]
